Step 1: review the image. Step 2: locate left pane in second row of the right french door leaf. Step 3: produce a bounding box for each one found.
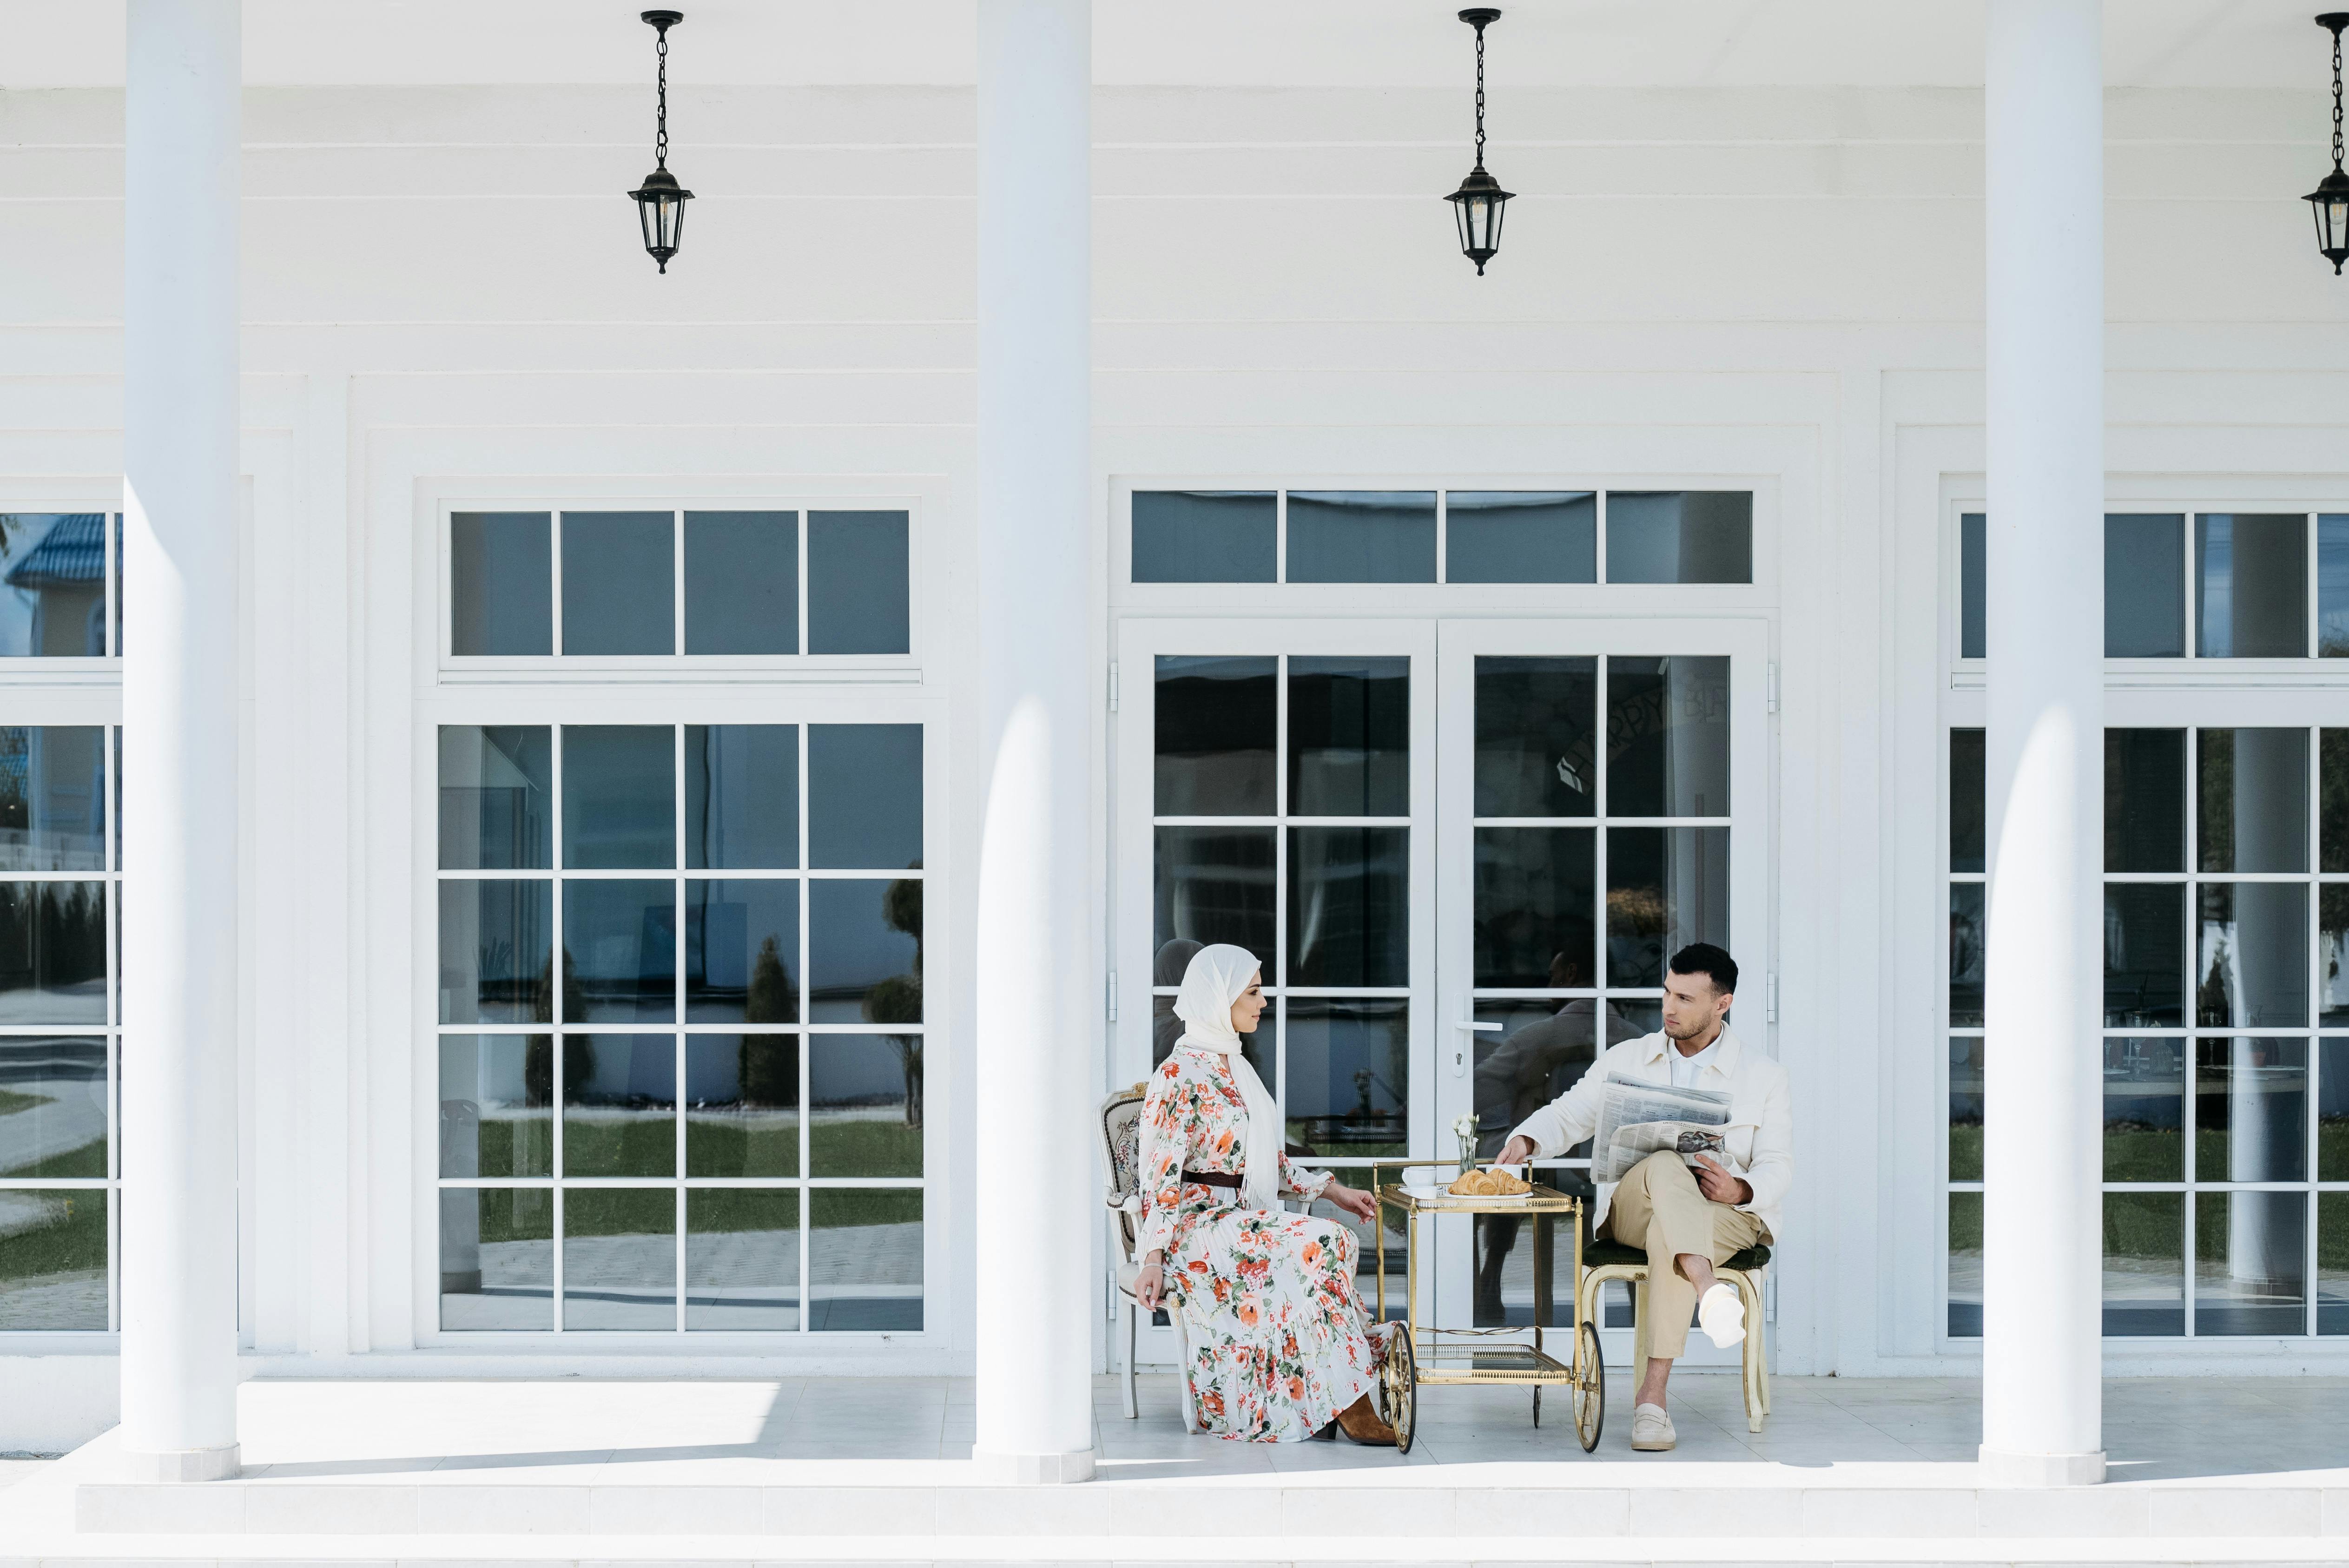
[1475,829,1597,988]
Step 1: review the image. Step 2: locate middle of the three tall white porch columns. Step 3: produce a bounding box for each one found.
[975,0,1102,1481]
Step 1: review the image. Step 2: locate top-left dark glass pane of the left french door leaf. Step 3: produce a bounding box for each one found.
[1154,655,1280,817]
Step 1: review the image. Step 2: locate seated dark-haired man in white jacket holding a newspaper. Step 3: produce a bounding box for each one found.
[1501,941,1795,1450]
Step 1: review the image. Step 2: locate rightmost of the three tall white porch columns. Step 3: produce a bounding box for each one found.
[1983,0,2105,1486]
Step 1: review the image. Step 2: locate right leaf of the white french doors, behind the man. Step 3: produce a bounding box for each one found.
[1435,619,1771,1357]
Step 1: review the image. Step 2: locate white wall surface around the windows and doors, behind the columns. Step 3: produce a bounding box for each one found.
[0,68,2349,1448]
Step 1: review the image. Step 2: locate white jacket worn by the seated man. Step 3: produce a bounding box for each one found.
[1513,1028,1795,1237]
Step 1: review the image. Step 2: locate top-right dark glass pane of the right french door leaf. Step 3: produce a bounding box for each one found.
[1607,657,1729,817]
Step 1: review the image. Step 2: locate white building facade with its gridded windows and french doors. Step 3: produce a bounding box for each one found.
[0,0,2349,1476]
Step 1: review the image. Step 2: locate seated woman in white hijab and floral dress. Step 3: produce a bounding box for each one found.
[1135,946,1395,1443]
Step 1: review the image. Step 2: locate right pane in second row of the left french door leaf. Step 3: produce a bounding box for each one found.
[1285,829,1412,986]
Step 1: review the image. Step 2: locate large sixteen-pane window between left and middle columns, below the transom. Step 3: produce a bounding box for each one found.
[437,723,928,1333]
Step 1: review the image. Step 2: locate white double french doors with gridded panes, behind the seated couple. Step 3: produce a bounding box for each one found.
[1111,617,1767,1362]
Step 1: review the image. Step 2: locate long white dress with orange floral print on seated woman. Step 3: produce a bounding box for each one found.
[1137,1047,1384,1443]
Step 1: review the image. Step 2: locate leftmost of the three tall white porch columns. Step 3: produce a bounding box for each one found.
[122,0,242,1481]
